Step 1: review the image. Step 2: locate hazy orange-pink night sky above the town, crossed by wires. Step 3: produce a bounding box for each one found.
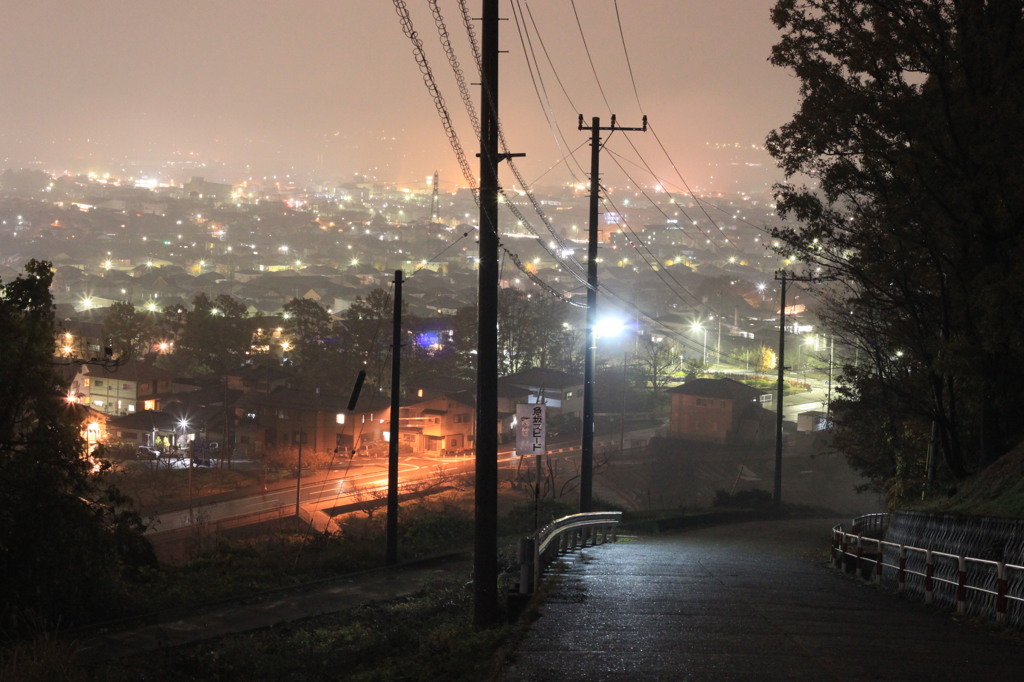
[0,0,798,190]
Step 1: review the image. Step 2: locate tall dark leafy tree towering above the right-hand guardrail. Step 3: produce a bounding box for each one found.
[768,0,1024,489]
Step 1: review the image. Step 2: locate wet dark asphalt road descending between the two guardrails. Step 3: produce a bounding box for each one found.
[502,519,1024,682]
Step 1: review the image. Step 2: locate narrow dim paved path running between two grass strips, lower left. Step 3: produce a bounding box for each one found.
[78,555,472,659]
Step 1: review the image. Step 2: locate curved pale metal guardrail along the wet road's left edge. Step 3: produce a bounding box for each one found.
[519,512,623,594]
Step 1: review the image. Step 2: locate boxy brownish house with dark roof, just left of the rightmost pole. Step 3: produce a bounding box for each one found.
[668,379,773,444]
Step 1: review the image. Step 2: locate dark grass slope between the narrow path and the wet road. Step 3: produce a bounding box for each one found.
[84,581,520,682]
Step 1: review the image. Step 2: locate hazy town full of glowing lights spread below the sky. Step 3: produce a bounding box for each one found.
[0,163,824,457]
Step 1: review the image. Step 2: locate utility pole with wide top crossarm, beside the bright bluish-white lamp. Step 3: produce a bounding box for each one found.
[579,114,647,512]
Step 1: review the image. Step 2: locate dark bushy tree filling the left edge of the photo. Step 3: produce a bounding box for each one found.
[0,260,153,632]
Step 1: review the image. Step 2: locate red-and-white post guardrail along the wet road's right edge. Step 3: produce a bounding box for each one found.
[831,514,1024,624]
